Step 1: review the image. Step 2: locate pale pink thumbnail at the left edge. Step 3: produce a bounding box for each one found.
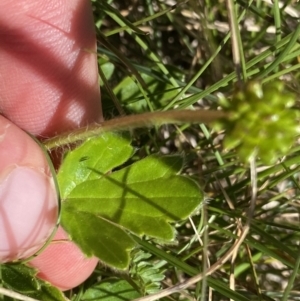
[0,166,58,262]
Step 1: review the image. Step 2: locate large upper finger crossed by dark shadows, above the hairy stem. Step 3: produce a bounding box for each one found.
[0,0,102,137]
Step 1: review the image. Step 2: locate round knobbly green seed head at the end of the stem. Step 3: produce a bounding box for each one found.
[217,81,300,164]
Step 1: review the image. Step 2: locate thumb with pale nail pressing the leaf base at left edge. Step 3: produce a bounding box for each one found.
[0,116,58,262]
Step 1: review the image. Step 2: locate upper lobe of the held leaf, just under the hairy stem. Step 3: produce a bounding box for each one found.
[57,133,133,199]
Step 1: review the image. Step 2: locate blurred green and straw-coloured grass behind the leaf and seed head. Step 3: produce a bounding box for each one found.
[76,0,300,301]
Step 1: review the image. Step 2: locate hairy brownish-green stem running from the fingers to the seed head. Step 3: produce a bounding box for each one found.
[43,110,226,150]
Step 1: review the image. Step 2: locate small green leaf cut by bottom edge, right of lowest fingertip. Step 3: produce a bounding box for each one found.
[82,279,141,301]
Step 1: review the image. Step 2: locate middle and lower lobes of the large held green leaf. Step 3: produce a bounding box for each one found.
[62,149,202,269]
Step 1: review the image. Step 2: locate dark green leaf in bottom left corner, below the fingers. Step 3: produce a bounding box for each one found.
[1,264,66,301]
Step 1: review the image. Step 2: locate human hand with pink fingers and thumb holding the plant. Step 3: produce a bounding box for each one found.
[0,0,102,290]
